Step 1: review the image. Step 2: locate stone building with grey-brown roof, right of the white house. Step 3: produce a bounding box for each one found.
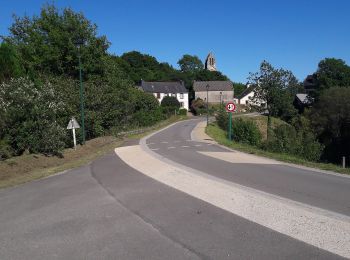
[193,81,234,104]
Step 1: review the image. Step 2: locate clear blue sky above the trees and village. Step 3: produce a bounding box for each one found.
[0,0,350,82]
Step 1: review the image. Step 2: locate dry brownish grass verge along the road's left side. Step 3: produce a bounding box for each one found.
[0,116,187,188]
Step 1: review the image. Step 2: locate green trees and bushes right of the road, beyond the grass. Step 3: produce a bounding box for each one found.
[218,58,350,164]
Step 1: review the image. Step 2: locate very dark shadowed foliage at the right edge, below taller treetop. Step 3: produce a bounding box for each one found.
[309,87,350,163]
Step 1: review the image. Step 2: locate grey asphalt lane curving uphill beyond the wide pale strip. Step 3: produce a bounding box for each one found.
[147,120,350,216]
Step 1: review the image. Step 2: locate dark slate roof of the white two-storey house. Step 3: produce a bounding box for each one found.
[141,80,188,93]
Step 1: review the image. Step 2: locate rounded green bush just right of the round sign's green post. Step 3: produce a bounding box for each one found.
[231,118,262,146]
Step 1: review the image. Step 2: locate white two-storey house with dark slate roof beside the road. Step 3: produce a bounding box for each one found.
[140,80,188,110]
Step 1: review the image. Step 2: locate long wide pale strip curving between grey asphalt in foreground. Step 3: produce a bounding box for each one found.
[115,145,350,258]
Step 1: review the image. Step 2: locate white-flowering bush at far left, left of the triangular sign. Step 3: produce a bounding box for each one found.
[0,78,66,157]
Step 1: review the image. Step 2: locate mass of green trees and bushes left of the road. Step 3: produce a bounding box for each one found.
[0,5,227,160]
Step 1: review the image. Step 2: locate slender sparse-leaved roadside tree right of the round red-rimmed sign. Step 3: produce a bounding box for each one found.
[248,61,300,139]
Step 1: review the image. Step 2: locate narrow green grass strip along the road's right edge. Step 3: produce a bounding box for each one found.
[206,123,350,174]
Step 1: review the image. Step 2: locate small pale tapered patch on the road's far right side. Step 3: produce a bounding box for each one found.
[198,152,280,164]
